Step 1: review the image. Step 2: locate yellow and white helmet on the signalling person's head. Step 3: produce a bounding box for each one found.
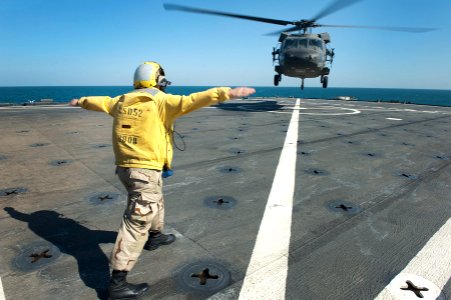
[133,61,171,90]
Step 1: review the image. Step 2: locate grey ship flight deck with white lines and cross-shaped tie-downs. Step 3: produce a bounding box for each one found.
[0,97,451,300]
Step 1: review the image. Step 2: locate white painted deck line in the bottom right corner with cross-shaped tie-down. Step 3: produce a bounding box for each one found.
[375,219,451,300]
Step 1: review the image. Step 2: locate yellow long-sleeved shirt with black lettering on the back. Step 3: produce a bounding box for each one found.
[78,87,229,170]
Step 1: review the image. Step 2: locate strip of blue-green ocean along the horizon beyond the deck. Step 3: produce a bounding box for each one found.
[0,86,451,106]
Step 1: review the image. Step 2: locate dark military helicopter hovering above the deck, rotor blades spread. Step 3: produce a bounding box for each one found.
[164,0,434,89]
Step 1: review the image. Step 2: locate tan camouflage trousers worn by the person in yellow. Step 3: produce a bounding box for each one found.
[110,167,164,271]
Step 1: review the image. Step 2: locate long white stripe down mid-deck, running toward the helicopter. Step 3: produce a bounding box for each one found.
[239,99,300,300]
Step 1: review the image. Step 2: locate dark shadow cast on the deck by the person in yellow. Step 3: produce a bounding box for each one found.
[4,207,117,299]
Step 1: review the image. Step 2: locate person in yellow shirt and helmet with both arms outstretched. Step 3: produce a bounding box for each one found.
[70,61,255,299]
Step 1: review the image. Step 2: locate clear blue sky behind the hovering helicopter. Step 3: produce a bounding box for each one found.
[0,0,451,89]
